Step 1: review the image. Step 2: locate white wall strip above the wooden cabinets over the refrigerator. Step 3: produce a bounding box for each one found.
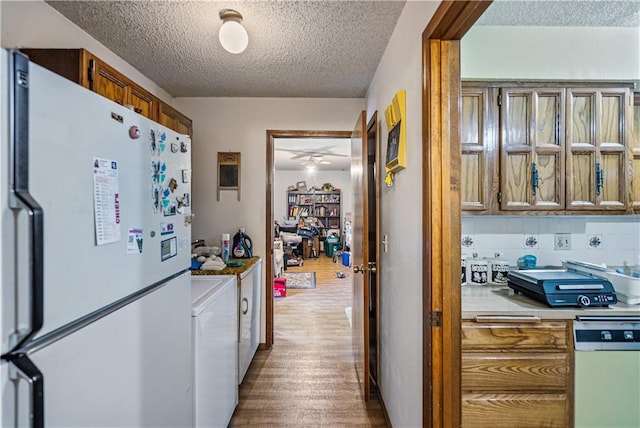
[0,0,172,104]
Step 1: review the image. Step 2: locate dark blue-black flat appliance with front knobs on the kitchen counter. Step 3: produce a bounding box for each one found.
[507,269,618,307]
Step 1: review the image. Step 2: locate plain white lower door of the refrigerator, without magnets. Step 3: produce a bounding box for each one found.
[8,273,193,428]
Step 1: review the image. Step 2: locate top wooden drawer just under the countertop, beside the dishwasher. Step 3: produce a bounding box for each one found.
[462,321,570,352]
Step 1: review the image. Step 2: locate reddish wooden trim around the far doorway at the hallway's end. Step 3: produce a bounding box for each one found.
[260,129,351,349]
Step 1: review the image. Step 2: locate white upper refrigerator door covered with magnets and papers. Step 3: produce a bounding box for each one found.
[11,55,191,337]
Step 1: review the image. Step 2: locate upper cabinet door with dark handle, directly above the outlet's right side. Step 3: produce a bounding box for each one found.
[567,88,630,210]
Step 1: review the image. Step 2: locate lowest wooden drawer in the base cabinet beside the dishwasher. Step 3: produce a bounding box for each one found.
[462,394,571,428]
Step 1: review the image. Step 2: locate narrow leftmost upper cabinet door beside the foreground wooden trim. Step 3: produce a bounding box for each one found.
[460,87,495,211]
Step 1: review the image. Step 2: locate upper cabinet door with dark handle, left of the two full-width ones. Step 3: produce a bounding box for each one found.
[500,88,564,210]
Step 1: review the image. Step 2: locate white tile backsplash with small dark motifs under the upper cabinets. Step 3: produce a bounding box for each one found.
[461,215,640,266]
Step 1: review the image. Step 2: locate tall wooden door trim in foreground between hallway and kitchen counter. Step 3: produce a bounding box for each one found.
[422,0,491,428]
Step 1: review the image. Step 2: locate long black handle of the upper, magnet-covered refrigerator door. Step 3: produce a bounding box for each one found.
[10,51,44,350]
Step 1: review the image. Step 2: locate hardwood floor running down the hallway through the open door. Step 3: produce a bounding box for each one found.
[230,254,387,427]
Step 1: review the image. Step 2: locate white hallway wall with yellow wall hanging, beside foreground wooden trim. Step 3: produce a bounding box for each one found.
[367,1,439,427]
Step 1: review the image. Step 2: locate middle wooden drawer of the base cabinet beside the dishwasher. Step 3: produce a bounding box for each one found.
[462,353,570,392]
